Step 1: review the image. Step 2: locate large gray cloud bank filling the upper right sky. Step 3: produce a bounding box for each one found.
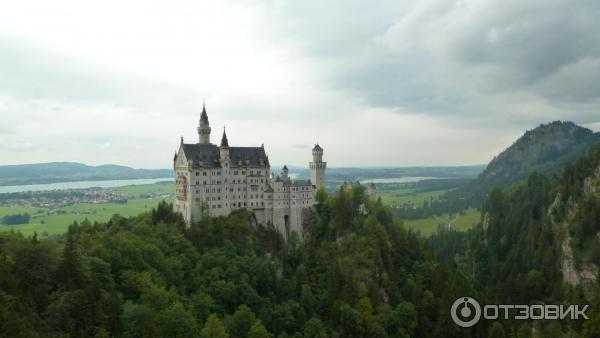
[272,0,600,123]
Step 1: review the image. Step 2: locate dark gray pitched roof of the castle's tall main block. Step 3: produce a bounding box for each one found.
[183,143,269,168]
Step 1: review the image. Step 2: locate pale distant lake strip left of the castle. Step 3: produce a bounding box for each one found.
[0,178,173,194]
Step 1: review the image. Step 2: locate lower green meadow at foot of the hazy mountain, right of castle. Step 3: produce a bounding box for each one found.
[403,208,481,236]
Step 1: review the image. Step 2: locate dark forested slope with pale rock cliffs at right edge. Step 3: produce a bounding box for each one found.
[428,145,600,337]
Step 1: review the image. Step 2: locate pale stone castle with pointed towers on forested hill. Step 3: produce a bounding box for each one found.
[173,106,327,240]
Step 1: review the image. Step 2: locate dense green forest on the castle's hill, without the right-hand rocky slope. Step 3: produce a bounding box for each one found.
[0,187,478,337]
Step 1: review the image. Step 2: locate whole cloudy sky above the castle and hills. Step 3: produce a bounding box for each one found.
[0,0,600,168]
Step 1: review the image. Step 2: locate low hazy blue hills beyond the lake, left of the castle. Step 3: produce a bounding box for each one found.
[0,162,173,186]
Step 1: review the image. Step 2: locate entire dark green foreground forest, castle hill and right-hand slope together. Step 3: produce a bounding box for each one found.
[0,146,600,338]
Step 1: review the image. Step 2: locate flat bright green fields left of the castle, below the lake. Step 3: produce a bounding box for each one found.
[0,183,173,237]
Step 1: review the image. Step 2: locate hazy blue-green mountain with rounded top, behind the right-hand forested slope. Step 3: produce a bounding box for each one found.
[397,121,600,218]
